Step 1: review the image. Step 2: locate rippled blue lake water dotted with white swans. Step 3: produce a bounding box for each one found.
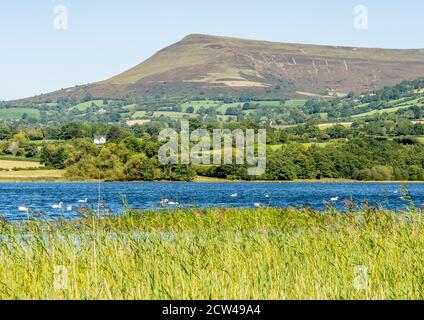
[0,183,424,221]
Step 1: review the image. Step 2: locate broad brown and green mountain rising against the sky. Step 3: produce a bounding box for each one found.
[14,34,424,102]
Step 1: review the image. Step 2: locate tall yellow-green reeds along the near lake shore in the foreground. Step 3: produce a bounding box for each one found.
[0,209,424,300]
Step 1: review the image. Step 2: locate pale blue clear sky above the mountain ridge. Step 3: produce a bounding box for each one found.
[0,0,424,100]
